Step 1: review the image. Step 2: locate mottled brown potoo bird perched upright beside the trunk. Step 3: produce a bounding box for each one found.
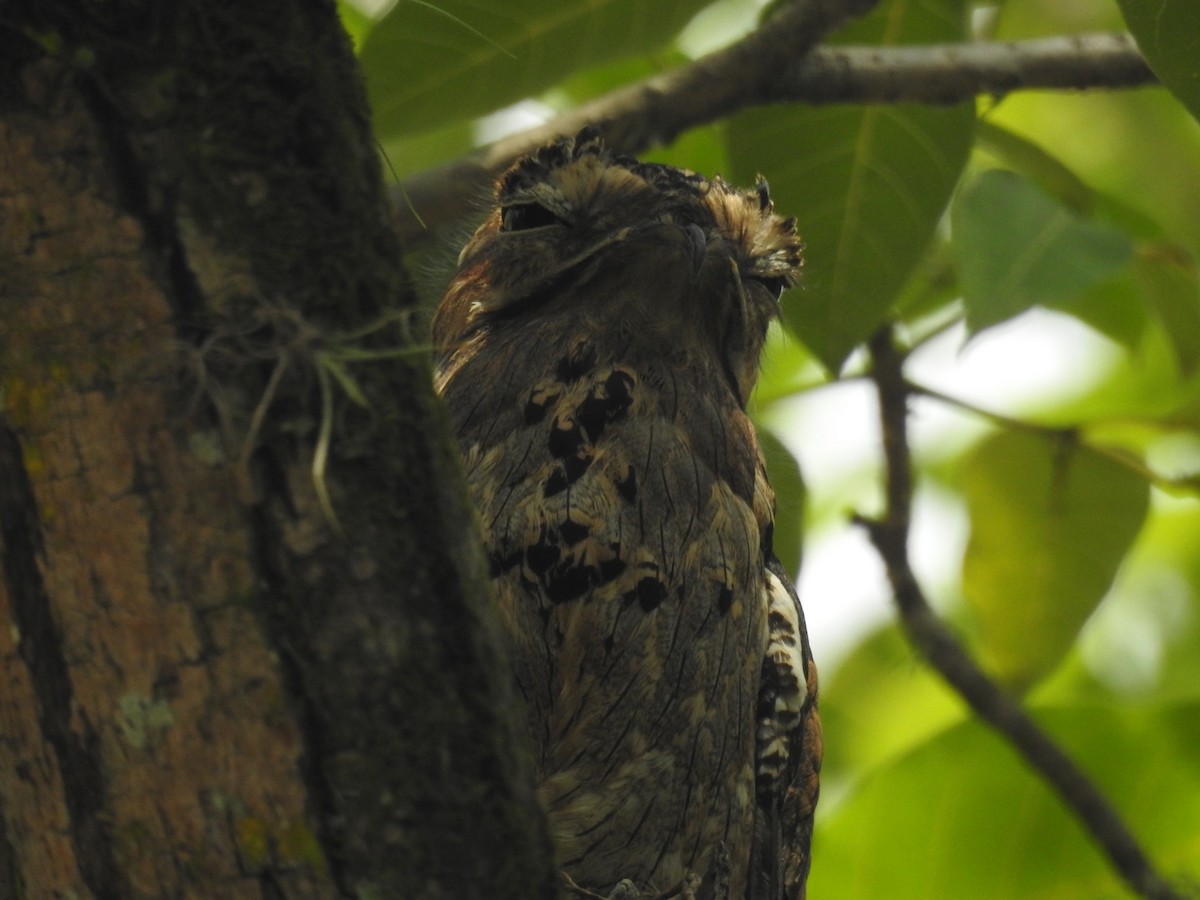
[433,131,821,900]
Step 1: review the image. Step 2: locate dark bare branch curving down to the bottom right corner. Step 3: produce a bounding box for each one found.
[858,329,1181,900]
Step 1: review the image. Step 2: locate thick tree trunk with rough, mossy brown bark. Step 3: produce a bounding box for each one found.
[0,0,553,900]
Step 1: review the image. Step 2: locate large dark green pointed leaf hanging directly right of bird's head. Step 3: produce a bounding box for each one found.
[727,0,974,371]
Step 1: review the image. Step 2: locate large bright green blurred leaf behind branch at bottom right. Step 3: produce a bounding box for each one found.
[809,703,1200,900]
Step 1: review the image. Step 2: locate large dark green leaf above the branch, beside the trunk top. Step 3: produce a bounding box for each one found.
[361,0,706,138]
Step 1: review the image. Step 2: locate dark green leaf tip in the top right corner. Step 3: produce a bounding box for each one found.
[1117,0,1200,120]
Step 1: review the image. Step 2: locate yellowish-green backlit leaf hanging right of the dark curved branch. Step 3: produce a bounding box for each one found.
[961,432,1150,688]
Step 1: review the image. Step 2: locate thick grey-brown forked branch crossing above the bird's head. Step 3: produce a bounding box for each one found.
[395,30,1154,244]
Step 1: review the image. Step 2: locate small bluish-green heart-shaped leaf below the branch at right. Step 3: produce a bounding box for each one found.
[952,169,1133,334]
